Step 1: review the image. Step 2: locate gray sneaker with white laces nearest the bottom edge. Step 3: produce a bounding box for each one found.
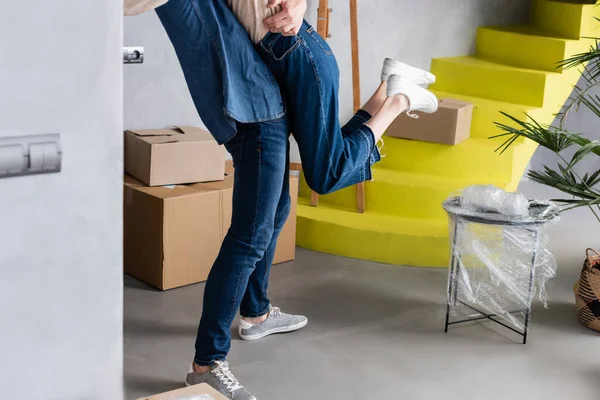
[185,361,256,400]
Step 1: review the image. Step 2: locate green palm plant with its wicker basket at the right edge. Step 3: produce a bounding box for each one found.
[493,30,600,331]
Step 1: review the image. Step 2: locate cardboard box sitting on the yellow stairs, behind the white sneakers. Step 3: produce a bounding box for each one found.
[386,99,473,145]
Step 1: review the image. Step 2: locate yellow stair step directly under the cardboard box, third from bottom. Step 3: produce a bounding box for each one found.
[378,137,536,182]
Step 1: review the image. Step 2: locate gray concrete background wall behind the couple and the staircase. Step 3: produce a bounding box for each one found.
[125,0,531,159]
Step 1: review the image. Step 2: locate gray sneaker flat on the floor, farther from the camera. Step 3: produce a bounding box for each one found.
[238,307,308,340]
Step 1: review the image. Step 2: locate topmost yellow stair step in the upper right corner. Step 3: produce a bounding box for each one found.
[532,0,600,39]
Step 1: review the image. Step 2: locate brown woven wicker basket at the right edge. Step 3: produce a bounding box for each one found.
[574,249,600,332]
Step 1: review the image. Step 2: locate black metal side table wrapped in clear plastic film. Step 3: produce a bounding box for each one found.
[443,197,558,344]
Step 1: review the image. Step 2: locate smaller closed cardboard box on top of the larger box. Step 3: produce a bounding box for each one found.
[125,126,225,186]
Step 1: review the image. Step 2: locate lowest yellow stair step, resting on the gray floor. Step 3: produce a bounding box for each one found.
[297,199,450,267]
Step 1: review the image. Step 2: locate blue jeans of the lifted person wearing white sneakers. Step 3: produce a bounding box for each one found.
[257,22,381,194]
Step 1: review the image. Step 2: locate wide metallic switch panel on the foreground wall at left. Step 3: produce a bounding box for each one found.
[0,133,62,179]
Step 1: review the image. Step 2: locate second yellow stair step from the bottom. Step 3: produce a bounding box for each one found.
[300,168,519,220]
